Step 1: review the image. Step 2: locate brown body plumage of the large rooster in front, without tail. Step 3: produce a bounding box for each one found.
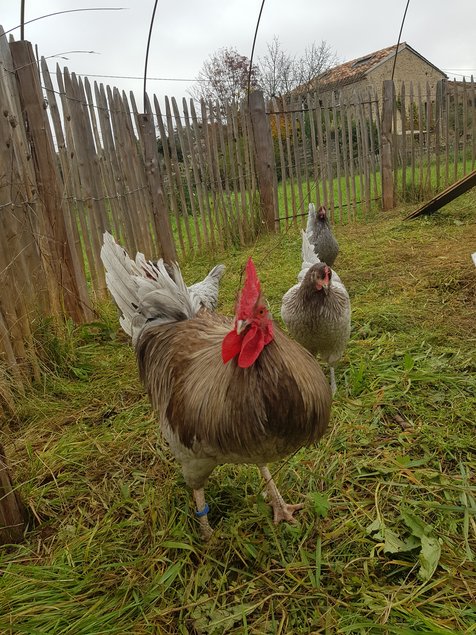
[137,313,330,489]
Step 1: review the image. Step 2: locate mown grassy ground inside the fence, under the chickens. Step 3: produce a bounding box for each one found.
[0,192,476,635]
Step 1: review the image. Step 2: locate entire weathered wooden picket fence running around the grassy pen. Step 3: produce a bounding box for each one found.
[0,31,476,402]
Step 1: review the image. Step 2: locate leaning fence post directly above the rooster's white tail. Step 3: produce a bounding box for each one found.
[137,104,177,263]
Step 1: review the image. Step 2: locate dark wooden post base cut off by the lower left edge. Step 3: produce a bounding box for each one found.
[0,445,27,545]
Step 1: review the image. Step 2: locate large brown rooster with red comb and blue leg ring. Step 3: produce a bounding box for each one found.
[101,235,331,539]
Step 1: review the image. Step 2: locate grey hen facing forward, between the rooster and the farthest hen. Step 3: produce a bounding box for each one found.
[281,232,350,394]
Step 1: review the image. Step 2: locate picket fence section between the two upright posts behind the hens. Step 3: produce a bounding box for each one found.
[269,90,382,227]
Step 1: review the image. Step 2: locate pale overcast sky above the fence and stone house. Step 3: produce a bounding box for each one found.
[0,0,476,107]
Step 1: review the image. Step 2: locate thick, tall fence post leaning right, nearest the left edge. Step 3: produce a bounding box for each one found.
[10,41,93,322]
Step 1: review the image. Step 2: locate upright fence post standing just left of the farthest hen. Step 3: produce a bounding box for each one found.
[249,90,279,232]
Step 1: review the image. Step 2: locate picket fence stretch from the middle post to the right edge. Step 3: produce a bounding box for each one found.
[269,80,476,227]
